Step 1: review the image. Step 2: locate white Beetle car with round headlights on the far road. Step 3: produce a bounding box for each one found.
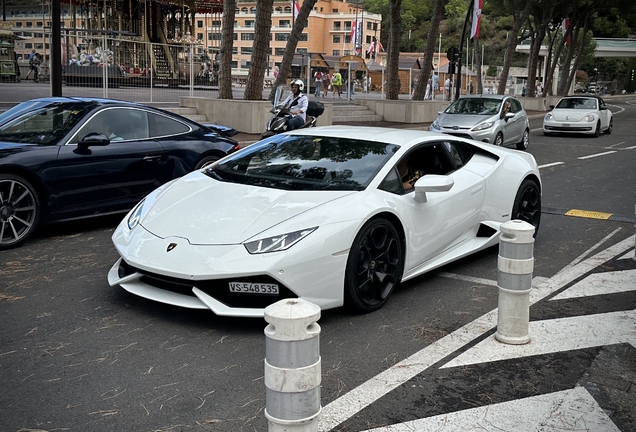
[543,96,614,137]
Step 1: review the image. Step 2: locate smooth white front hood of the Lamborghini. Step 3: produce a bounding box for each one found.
[141,172,355,245]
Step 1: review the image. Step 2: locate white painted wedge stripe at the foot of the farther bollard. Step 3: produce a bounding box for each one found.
[440,309,636,369]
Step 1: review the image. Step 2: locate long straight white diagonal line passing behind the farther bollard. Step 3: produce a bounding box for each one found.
[318,236,634,432]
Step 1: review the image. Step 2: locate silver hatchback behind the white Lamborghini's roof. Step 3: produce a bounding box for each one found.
[429,95,530,150]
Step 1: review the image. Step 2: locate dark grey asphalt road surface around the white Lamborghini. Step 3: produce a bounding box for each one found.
[0,97,636,432]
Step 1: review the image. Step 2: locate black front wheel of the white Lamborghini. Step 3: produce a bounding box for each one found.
[344,219,404,313]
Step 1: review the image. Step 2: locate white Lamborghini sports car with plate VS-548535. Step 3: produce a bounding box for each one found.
[108,126,541,317]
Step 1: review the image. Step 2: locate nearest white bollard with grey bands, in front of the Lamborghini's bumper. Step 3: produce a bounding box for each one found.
[265,299,322,432]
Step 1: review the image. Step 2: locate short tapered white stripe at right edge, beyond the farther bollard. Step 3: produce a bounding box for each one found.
[550,270,636,301]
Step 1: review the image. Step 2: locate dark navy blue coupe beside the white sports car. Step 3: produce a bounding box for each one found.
[0,97,239,249]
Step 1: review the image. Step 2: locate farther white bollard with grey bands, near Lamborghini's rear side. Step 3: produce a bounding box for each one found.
[495,220,534,345]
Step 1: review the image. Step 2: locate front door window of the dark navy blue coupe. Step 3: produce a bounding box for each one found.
[71,108,148,144]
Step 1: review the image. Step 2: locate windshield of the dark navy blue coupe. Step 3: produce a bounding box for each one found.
[0,102,90,145]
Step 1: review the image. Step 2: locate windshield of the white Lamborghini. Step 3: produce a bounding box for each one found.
[206,135,399,191]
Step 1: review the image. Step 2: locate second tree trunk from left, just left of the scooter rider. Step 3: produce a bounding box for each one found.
[244,0,274,100]
